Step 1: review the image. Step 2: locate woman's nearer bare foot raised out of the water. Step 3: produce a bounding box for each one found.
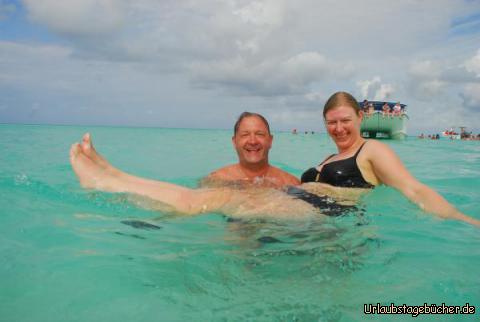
[70,143,118,192]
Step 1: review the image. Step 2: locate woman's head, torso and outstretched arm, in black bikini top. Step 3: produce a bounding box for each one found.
[301,92,480,225]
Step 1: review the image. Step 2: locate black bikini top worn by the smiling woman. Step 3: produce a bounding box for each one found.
[302,143,375,188]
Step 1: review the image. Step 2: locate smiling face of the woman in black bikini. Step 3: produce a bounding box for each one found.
[325,105,363,152]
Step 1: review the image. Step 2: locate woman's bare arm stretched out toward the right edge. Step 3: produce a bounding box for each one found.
[367,140,480,226]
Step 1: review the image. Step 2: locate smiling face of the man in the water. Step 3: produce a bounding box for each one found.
[232,116,273,166]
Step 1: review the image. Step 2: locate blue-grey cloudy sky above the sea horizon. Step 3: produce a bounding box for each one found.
[0,0,480,134]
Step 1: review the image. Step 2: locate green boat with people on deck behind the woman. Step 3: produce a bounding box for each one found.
[359,100,409,140]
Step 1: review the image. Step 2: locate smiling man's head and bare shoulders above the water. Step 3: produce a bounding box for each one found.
[202,112,300,188]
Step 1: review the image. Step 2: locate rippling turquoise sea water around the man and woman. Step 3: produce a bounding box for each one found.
[0,125,480,322]
